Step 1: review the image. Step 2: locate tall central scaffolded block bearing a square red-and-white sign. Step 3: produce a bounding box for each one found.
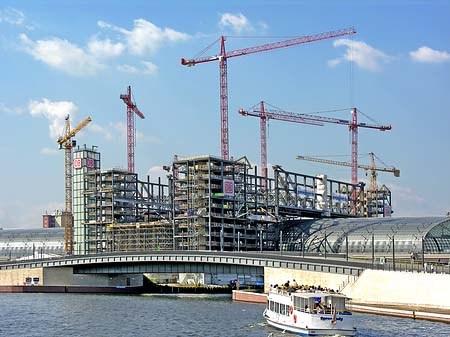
[173,156,257,251]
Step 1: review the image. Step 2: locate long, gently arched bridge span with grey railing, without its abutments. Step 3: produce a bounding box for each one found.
[0,251,368,275]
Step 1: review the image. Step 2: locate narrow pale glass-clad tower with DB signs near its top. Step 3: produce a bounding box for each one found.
[73,145,100,255]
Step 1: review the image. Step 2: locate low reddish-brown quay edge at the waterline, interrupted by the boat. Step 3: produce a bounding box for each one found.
[232,290,450,324]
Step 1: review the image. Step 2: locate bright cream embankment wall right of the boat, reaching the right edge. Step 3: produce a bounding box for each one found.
[343,270,450,309]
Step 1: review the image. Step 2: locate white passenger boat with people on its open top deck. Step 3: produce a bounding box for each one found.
[264,291,356,336]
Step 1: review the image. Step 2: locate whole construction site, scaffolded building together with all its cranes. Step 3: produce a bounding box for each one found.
[53,28,408,254]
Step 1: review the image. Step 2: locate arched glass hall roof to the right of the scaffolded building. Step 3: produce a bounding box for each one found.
[305,217,450,255]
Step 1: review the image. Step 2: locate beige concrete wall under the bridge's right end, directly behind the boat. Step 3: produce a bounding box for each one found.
[264,267,355,292]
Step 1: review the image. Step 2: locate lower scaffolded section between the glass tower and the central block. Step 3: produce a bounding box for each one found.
[84,169,173,254]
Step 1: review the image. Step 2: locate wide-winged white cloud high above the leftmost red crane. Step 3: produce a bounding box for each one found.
[98,19,190,56]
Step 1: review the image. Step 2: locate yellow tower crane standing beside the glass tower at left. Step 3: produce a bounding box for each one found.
[57,115,92,255]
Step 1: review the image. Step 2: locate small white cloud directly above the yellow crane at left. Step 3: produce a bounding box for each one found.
[28,98,78,140]
